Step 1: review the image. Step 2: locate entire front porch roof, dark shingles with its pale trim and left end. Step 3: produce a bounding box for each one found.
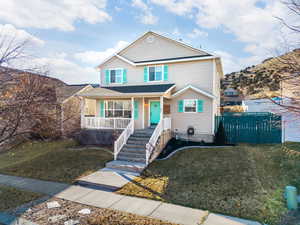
[79,84,175,98]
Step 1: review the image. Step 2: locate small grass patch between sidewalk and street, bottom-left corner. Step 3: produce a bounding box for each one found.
[0,185,42,211]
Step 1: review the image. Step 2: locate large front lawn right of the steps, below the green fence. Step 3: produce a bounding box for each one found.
[118,143,300,224]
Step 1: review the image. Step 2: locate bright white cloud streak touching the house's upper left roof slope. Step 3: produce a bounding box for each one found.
[74,41,128,66]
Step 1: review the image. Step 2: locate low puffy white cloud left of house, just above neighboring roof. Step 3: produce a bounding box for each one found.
[32,52,99,84]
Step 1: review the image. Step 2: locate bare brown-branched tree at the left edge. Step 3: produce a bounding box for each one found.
[0,30,52,149]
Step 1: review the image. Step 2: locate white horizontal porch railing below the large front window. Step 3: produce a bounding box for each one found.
[82,117,131,129]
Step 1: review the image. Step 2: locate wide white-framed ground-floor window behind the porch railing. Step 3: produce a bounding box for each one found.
[105,100,131,118]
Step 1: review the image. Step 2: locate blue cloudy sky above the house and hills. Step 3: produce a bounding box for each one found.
[0,0,295,84]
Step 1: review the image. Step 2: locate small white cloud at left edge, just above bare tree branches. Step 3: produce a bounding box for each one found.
[0,24,45,46]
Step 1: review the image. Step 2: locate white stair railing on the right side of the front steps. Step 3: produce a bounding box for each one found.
[146,118,171,165]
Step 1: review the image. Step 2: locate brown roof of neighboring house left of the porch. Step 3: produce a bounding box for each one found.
[56,84,92,103]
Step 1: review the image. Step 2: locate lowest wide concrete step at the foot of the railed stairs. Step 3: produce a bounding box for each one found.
[106,160,146,173]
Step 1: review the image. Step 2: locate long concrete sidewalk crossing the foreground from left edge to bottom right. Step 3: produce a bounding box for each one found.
[0,175,259,225]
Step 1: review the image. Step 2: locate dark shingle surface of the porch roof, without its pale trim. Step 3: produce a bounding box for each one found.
[102,84,174,93]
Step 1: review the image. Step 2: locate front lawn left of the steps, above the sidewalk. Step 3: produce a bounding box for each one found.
[0,140,113,183]
